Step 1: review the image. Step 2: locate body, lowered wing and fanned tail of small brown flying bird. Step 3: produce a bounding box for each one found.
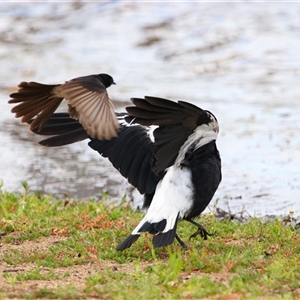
[9,74,119,140]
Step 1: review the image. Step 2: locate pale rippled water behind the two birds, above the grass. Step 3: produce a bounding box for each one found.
[0,1,300,216]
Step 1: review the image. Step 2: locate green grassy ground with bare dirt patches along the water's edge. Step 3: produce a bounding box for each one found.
[0,184,300,299]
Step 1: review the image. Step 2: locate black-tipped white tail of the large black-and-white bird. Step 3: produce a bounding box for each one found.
[116,213,179,251]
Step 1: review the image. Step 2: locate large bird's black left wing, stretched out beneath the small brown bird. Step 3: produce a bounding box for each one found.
[29,113,163,195]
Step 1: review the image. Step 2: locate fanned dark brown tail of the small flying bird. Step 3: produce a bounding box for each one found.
[9,82,63,131]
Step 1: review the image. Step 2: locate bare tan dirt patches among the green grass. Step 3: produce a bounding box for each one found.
[0,236,232,299]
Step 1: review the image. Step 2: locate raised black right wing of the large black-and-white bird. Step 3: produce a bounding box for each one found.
[126,96,208,174]
